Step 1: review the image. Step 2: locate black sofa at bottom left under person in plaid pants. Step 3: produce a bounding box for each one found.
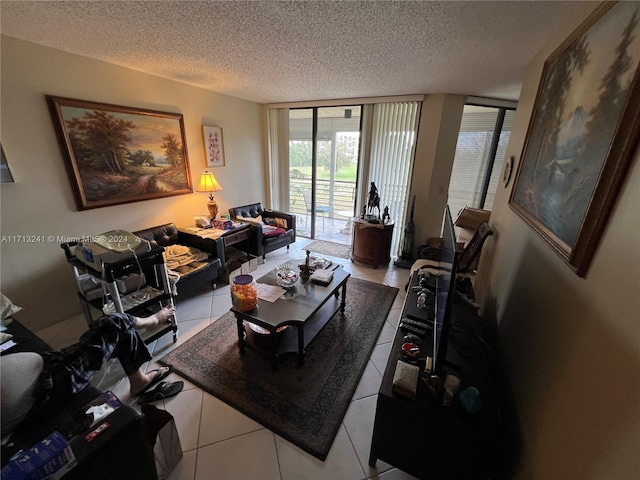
[0,319,157,480]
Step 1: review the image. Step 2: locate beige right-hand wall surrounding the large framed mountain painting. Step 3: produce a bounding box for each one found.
[477,4,640,480]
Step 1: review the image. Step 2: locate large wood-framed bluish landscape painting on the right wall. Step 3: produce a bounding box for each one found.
[509,2,640,276]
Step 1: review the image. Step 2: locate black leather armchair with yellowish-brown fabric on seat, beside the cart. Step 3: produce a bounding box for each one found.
[132,223,224,295]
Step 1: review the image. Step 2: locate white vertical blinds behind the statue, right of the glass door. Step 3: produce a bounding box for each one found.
[362,102,421,255]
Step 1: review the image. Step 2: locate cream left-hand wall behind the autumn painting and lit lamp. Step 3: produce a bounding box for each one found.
[0,36,265,329]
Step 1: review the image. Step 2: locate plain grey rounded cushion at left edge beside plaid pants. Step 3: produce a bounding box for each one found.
[0,352,43,437]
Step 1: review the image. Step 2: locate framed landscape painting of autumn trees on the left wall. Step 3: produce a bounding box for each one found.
[47,95,192,210]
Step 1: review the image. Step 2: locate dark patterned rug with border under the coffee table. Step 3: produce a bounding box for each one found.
[160,278,398,460]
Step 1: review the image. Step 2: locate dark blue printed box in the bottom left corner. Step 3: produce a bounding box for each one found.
[2,432,77,480]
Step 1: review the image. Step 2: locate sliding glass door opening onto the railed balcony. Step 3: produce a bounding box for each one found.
[289,105,362,240]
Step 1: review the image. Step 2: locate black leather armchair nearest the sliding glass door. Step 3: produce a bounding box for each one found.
[229,203,296,260]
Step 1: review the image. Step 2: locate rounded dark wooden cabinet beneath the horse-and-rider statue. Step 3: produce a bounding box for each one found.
[351,217,394,268]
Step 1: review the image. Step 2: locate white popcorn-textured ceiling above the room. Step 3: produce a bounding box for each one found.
[0,0,595,103]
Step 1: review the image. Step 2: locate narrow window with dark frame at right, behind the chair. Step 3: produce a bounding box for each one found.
[448,105,515,216]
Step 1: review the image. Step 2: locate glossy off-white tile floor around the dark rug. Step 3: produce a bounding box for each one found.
[38,239,414,480]
